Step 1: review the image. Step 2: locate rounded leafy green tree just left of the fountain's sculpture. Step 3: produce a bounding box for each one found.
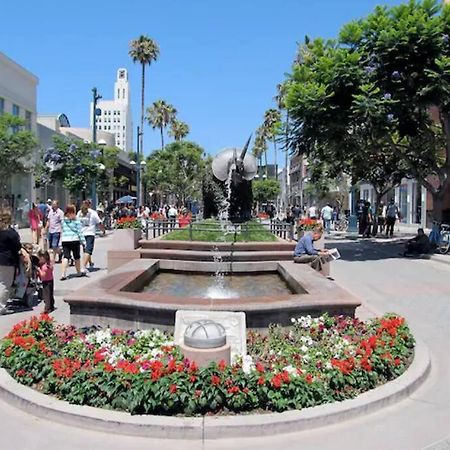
[145,141,205,204]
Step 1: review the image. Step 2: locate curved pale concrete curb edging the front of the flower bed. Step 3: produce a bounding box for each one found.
[0,341,431,440]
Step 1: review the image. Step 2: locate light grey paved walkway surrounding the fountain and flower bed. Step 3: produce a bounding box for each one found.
[0,236,450,450]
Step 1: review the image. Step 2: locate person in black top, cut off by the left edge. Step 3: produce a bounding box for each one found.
[0,209,21,315]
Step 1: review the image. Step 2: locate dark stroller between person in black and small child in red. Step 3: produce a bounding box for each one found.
[13,244,41,308]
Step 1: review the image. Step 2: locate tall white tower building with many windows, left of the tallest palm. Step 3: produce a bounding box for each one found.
[90,69,133,152]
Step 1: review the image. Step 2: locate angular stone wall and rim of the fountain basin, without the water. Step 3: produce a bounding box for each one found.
[64,259,361,330]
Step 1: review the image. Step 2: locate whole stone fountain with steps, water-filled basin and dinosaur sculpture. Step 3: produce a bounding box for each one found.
[65,139,361,329]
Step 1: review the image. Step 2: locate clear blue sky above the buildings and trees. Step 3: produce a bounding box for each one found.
[0,0,400,160]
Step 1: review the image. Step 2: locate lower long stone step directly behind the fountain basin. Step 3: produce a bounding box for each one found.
[140,248,293,261]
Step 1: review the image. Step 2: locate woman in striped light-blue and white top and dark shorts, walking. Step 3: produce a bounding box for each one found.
[61,205,86,281]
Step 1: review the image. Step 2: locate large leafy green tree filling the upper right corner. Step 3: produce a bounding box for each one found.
[287,0,450,220]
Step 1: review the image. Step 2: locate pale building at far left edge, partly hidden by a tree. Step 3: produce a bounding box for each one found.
[0,52,39,224]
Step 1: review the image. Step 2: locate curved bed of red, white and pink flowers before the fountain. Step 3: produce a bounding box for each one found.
[0,315,414,415]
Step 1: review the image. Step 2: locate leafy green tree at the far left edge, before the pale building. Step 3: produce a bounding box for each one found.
[0,113,37,196]
